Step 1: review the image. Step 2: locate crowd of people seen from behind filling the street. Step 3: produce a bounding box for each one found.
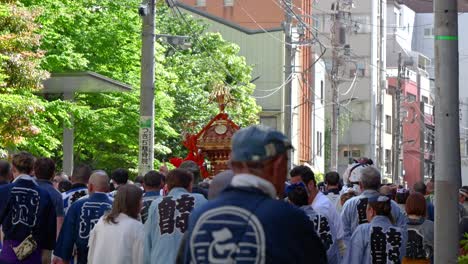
[0,126,468,264]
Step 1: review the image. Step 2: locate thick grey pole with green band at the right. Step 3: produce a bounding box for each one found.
[434,0,461,263]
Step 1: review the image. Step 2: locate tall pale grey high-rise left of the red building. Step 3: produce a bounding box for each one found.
[313,0,392,177]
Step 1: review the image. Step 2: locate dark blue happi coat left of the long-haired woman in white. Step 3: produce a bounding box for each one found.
[54,193,112,264]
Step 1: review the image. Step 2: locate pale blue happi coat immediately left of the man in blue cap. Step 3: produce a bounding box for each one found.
[143,188,206,264]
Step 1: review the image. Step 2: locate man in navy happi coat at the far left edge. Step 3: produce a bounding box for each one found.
[0,152,56,264]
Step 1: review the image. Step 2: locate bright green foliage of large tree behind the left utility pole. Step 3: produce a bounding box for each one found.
[0,0,259,169]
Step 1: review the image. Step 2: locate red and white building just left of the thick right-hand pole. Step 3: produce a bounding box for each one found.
[388,68,434,188]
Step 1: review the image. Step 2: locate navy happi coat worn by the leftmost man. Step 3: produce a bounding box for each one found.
[0,175,57,250]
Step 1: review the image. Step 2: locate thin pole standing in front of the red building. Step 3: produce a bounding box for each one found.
[392,52,403,184]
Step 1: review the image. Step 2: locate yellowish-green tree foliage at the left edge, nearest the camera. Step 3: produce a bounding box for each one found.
[0,1,68,159]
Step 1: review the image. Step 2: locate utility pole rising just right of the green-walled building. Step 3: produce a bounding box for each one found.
[283,0,294,167]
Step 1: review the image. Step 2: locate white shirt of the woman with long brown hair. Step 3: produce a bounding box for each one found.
[88,213,144,264]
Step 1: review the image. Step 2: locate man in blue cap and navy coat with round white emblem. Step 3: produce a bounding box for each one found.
[183,125,327,264]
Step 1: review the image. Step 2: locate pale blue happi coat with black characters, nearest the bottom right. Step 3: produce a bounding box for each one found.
[343,216,407,264]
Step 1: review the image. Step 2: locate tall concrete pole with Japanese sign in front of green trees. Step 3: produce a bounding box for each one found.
[138,0,156,175]
